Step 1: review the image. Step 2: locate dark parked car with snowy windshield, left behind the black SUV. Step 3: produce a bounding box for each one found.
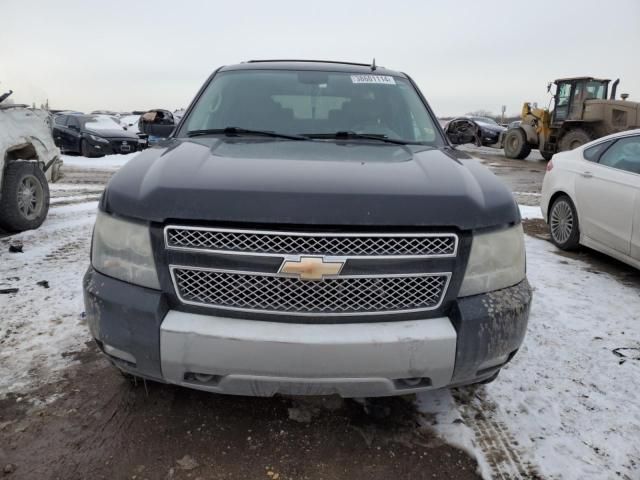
[53,114,146,157]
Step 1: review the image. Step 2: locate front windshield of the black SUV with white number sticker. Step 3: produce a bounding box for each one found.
[178,70,444,146]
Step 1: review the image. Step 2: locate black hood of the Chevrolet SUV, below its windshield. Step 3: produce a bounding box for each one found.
[100,137,520,229]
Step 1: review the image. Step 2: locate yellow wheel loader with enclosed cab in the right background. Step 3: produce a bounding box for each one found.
[501,77,640,160]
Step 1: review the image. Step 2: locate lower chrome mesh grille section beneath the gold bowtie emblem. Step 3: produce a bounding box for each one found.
[171,266,450,315]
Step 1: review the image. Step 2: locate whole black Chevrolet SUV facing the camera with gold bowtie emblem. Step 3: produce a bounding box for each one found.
[84,60,531,397]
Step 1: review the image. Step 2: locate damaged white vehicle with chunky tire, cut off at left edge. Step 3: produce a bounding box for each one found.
[0,92,62,232]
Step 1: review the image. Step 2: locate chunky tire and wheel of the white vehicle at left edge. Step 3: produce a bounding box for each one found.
[0,161,49,232]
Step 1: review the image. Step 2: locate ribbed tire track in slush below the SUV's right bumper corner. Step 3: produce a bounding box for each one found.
[454,387,543,480]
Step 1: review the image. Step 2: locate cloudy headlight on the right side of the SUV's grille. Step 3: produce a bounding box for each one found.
[459,224,526,297]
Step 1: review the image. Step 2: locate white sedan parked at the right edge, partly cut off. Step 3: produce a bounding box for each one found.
[540,130,640,268]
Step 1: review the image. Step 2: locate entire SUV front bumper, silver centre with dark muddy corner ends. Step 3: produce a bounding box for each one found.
[84,268,531,397]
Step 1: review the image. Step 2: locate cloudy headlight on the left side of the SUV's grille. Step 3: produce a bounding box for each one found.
[91,212,160,290]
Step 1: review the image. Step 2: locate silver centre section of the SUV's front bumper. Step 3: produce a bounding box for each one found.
[160,311,456,397]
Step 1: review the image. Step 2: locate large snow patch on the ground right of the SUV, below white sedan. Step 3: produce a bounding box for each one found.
[419,235,640,480]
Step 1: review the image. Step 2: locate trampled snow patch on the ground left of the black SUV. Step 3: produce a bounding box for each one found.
[0,202,98,396]
